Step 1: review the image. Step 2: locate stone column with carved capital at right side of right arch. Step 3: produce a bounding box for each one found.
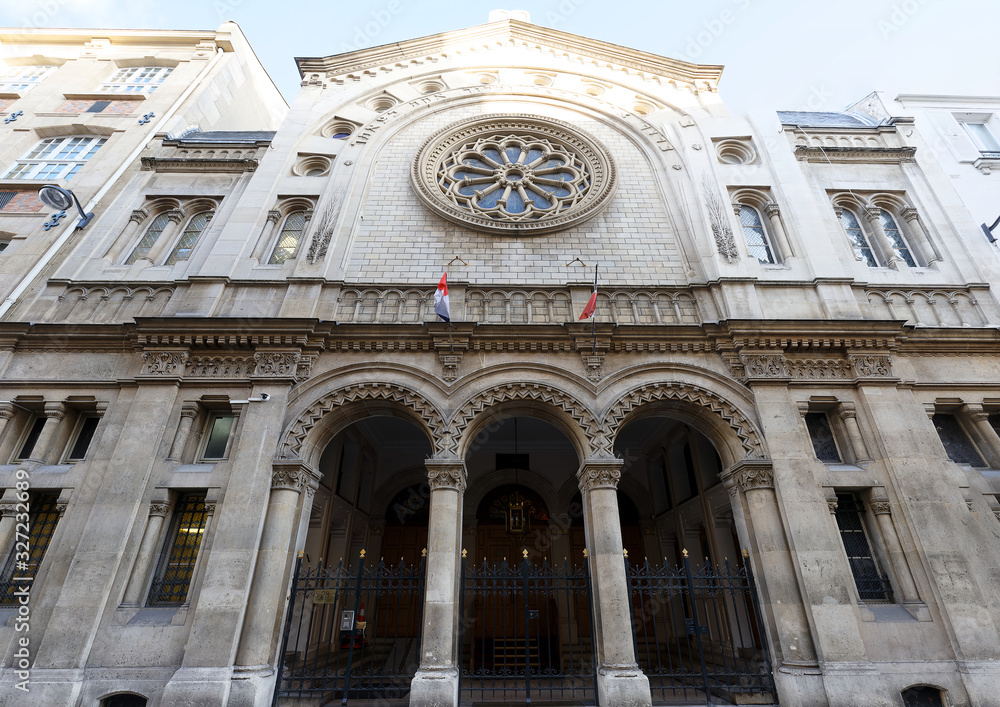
[722,459,817,670]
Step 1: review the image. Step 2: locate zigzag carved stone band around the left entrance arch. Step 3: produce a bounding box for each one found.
[281,383,444,459]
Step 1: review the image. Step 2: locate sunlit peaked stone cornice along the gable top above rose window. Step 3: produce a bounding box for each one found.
[295,20,723,85]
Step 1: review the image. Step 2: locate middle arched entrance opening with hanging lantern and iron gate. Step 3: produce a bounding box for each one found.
[460,415,595,704]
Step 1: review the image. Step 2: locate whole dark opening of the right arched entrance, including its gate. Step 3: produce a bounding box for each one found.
[615,413,774,704]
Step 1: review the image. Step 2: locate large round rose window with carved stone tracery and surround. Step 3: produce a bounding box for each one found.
[412,115,615,234]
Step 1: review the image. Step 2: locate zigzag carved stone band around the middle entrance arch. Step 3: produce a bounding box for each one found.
[447,383,600,458]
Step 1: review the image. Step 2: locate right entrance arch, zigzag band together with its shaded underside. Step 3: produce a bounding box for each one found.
[601,383,766,466]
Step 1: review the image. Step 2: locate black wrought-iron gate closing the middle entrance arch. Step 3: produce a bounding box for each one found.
[460,557,597,704]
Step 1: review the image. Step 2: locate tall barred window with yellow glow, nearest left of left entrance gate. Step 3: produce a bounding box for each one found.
[146,493,208,606]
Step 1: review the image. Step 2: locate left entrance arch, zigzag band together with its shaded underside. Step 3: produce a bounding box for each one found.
[280,383,445,461]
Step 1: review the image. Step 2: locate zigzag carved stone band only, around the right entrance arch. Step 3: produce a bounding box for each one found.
[600,383,765,459]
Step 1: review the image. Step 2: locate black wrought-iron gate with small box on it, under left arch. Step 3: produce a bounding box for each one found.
[272,552,424,705]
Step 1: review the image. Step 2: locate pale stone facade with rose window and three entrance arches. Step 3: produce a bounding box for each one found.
[0,12,1000,707]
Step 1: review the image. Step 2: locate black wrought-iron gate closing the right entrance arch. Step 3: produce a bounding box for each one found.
[626,552,774,704]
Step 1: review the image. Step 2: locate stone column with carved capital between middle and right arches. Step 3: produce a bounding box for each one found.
[577,459,652,707]
